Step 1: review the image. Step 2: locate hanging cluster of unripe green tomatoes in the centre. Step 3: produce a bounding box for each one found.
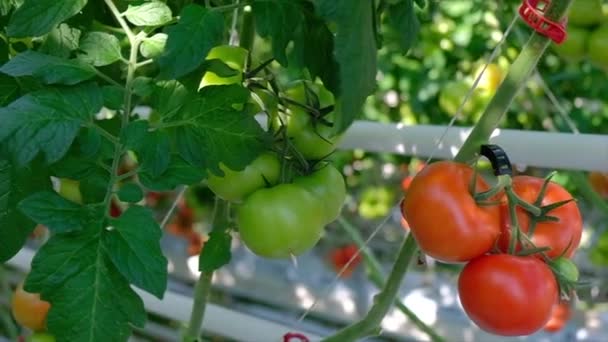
[201,55,346,258]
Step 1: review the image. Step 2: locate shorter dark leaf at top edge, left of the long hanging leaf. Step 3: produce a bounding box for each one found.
[251,0,304,66]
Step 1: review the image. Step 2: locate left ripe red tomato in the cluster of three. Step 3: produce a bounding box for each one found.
[401,161,500,262]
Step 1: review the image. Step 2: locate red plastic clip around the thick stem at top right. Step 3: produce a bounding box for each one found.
[519,0,568,44]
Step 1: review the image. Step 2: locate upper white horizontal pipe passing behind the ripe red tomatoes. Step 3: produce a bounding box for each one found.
[339,121,608,172]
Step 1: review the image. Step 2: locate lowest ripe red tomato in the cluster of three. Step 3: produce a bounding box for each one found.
[458,254,559,336]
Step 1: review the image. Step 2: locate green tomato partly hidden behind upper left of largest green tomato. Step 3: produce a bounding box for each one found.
[207,152,281,202]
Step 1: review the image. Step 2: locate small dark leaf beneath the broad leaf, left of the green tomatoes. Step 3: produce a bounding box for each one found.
[139,154,206,191]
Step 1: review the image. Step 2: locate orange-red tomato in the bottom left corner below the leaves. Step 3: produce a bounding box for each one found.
[11,284,51,331]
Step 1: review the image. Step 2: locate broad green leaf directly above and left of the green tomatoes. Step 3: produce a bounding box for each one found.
[162,84,267,174]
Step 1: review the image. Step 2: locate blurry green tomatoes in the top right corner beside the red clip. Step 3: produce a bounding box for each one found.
[553,0,608,70]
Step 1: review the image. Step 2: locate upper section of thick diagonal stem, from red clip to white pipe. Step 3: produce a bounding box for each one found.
[454,0,573,164]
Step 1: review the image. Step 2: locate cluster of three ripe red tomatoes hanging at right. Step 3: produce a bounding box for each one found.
[401,161,582,336]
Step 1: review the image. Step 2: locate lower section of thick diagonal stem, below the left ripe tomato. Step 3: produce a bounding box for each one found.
[322,227,418,342]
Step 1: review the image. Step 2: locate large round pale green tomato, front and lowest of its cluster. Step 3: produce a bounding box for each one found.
[237,184,325,259]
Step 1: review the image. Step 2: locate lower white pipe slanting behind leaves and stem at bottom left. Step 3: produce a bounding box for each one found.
[7,248,321,342]
